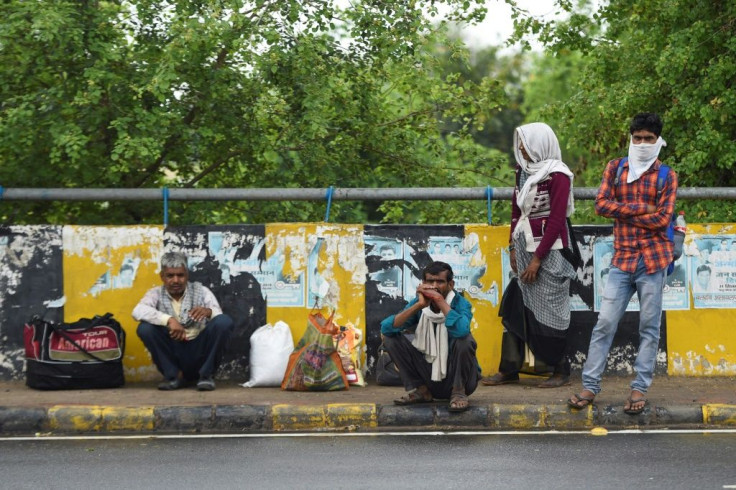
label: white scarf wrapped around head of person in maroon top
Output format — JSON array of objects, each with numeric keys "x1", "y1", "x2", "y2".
[{"x1": 514, "y1": 123, "x2": 575, "y2": 219}]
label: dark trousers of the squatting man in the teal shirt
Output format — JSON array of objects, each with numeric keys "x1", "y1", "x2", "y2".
[{"x1": 383, "y1": 335, "x2": 480, "y2": 399}]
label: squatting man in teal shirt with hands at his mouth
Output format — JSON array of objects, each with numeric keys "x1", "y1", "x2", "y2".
[{"x1": 381, "y1": 262, "x2": 480, "y2": 412}]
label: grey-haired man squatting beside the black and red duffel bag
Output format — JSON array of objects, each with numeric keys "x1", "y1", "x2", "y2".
[{"x1": 133, "y1": 252, "x2": 233, "y2": 391}]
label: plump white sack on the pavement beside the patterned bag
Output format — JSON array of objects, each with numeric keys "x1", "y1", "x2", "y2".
[{"x1": 243, "y1": 321, "x2": 294, "y2": 388}]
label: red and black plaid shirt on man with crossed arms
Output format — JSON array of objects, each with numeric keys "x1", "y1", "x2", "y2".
[{"x1": 595, "y1": 158, "x2": 677, "y2": 274}]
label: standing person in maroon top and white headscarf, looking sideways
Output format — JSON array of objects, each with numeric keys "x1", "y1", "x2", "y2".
[{"x1": 481, "y1": 123, "x2": 576, "y2": 388}]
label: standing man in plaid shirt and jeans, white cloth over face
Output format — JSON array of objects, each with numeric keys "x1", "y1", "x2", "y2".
[{"x1": 568, "y1": 113, "x2": 677, "y2": 414}]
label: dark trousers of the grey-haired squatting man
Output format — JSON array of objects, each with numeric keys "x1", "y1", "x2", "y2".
[{"x1": 137, "y1": 314, "x2": 233, "y2": 381}]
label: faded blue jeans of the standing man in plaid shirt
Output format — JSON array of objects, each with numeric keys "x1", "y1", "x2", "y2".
[{"x1": 583, "y1": 258, "x2": 667, "y2": 395}]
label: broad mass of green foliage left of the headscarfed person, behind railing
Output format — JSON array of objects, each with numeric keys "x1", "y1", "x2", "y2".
[{"x1": 0, "y1": 0, "x2": 508, "y2": 224}]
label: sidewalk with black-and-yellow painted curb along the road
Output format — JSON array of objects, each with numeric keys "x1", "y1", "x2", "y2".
[{"x1": 0, "y1": 376, "x2": 736, "y2": 436}]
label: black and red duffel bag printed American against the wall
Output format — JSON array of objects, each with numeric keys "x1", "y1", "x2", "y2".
[{"x1": 23, "y1": 313, "x2": 125, "y2": 390}]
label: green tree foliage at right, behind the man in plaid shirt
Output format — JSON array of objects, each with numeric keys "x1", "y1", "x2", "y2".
[{"x1": 516, "y1": 0, "x2": 736, "y2": 221}]
